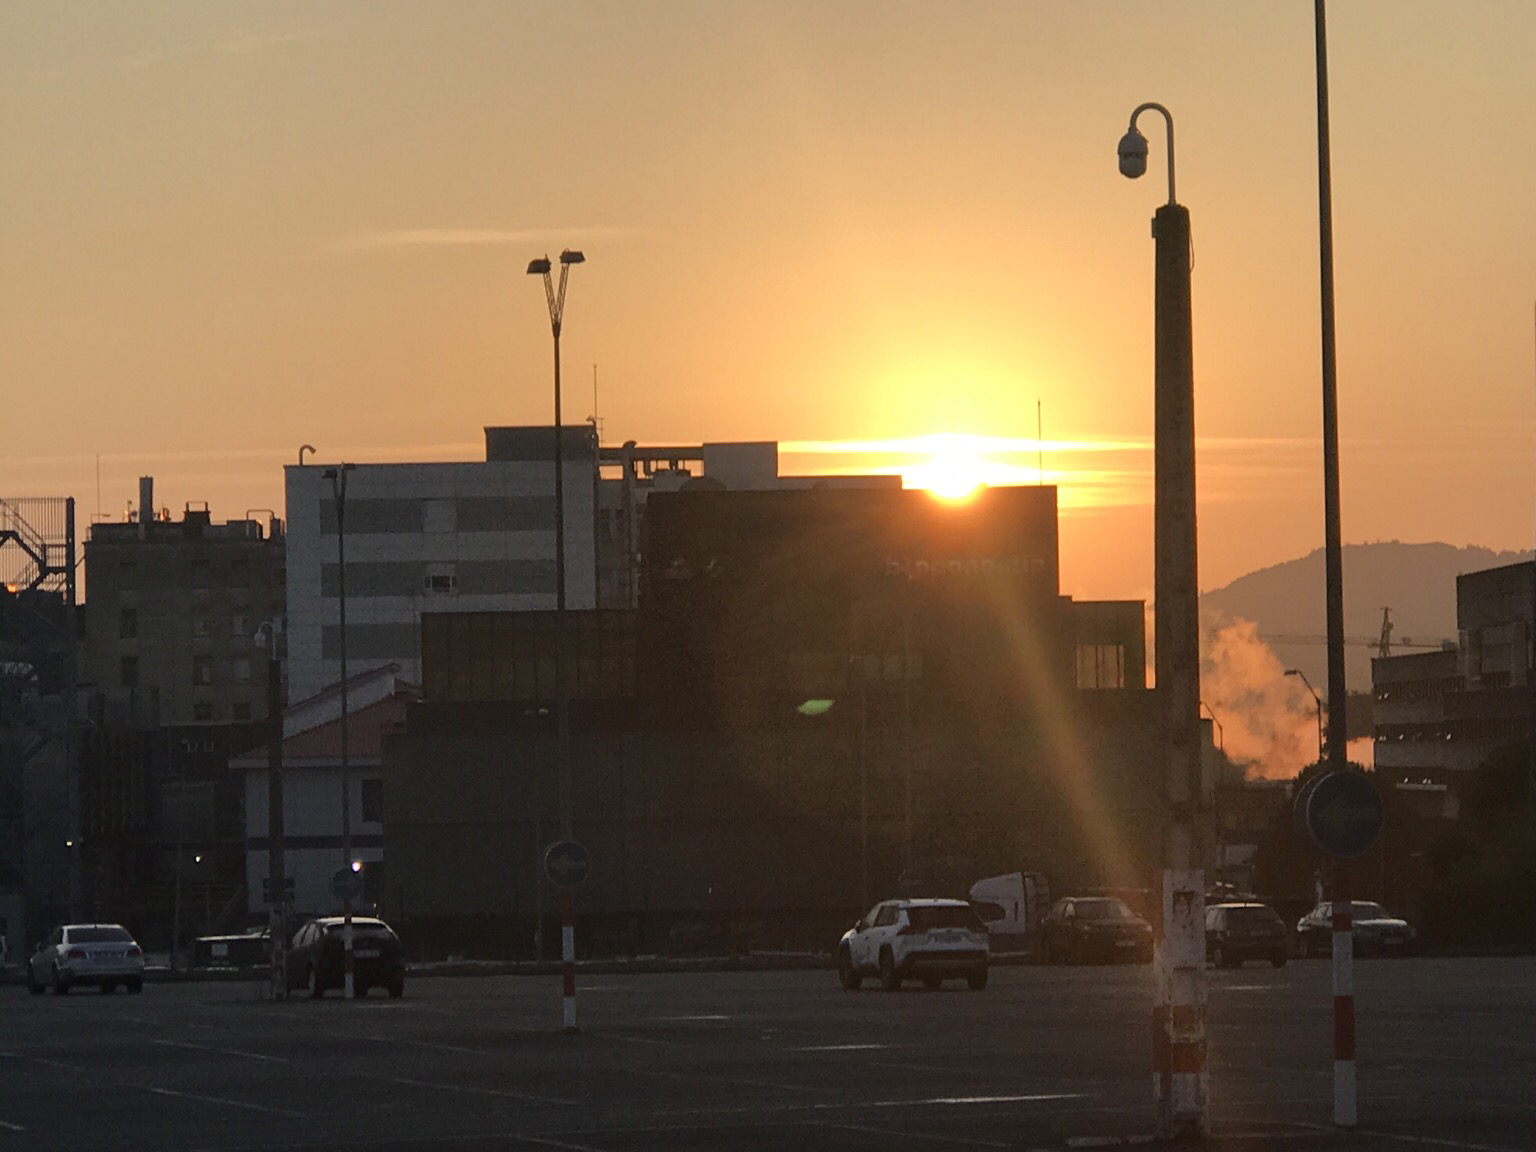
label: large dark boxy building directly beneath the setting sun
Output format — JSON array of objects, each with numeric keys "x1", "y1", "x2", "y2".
[{"x1": 384, "y1": 487, "x2": 1161, "y2": 954}]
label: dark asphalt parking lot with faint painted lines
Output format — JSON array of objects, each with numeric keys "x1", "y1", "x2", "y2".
[{"x1": 0, "y1": 957, "x2": 1536, "y2": 1152}]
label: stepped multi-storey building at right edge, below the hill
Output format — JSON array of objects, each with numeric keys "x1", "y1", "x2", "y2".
[{"x1": 1372, "y1": 562, "x2": 1536, "y2": 816}]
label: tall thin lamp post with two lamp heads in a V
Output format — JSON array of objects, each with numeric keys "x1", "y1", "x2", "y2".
[{"x1": 528, "y1": 249, "x2": 587, "y2": 1032}]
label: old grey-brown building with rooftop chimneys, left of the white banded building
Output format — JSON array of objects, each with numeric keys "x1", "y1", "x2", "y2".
[{"x1": 80, "y1": 478, "x2": 284, "y2": 728}]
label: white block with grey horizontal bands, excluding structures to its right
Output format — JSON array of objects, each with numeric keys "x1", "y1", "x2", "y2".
[{"x1": 286, "y1": 424, "x2": 598, "y2": 700}]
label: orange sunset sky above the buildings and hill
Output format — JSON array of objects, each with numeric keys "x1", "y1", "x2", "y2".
[{"x1": 0, "y1": 0, "x2": 1536, "y2": 596}]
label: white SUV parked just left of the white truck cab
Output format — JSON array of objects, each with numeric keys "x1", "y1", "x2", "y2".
[{"x1": 837, "y1": 900, "x2": 988, "y2": 992}]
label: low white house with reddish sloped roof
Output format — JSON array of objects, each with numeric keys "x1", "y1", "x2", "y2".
[{"x1": 229, "y1": 665, "x2": 418, "y2": 919}]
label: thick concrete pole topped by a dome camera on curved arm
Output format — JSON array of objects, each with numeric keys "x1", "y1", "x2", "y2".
[{"x1": 1118, "y1": 103, "x2": 1206, "y2": 1140}]
